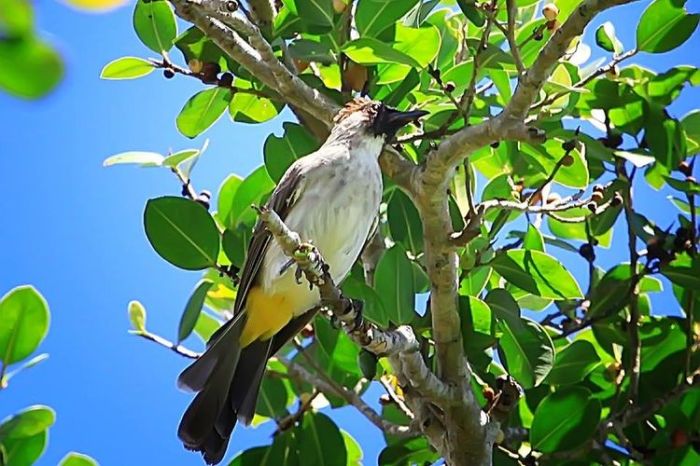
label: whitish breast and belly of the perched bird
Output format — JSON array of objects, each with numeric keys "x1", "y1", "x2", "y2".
[{"x1": 261, "y1": 139, "x2": 382, "y2": 315}]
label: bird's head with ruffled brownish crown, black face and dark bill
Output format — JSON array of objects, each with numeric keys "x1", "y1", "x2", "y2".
[{"x1": 333, "y1": 97, "x2": 428, "y2": 142}]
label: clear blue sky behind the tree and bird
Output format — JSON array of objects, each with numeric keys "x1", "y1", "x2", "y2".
[{"x1": 0, "y1": 0, "x2": 700, "y2": 466}]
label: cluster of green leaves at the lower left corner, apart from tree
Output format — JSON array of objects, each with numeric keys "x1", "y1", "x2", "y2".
[{"x1": 0, "y1": 285, "x2": 97, "y2": 466}]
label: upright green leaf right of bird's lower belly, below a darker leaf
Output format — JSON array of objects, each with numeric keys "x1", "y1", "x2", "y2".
[{"x1": 374, "y1": 244, "x2": 415, "y2": 324}]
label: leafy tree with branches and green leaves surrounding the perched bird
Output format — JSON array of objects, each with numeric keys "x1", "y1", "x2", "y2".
[{"x1": 0, "y1": 0, "x2": 700, "y2": 466}]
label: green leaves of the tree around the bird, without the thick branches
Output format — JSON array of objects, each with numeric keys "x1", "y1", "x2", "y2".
[{"x1": 103, "y1": 0, "x2": 700, "y2": 465}]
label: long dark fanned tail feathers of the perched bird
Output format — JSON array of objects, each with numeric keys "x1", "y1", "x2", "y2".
[{"x1": 177, "y1": 315, "x2": 271, "y2": 464}]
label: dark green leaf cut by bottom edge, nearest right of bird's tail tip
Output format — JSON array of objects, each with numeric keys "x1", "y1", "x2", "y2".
[{"x1": 297, "y1": 411, "x2": 348, "y2": 466}]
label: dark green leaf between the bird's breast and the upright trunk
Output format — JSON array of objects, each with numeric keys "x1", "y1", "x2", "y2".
[{"x1": 387, "y1": 189, "x2": 423, "y2": 255}]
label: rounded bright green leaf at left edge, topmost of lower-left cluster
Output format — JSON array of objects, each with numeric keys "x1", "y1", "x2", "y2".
[{"x1": 0, "y1": 285, "x2": 50, "y2": 366}]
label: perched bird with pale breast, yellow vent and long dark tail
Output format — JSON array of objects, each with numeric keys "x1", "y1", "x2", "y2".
[{"x1": 178, "y1": 97, "x2": 428, "y2": 464}]
